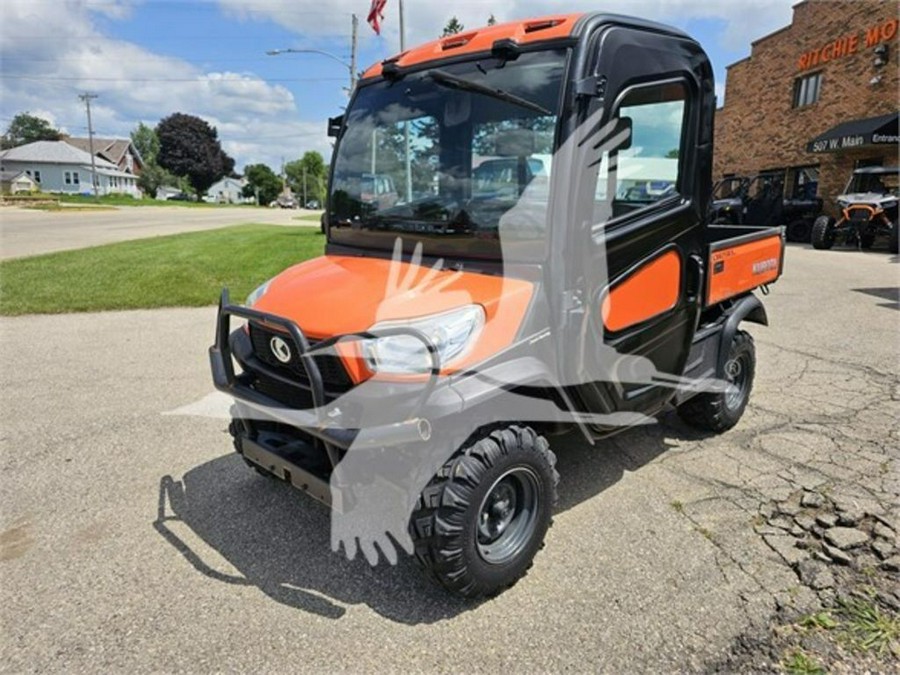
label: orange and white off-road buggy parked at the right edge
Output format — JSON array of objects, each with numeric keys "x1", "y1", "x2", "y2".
[{"x1": 812, "y1": 166, "x2": 900, "y2": 253}]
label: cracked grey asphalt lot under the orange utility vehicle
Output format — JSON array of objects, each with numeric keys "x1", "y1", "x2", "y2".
[{"x1": 0, "y1": 248, "x2": 900, "y2": 673}]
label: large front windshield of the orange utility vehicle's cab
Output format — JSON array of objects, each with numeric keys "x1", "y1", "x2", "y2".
[{"x1": 329, "y1": 50, "x2": 566, "y2": 260}]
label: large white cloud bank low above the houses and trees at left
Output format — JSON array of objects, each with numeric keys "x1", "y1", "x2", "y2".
[{"x1": 0, "y1": 0, "x2": 330, "y2": 168}]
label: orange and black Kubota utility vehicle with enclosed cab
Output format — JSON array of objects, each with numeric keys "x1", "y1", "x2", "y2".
[{"x1": 210, "y1": 13, "x2": 784, "y2": 596}]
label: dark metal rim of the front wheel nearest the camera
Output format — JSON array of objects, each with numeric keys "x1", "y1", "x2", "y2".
[{"x1": 475, "y1": 466, "x2": 541, "y2": 565}]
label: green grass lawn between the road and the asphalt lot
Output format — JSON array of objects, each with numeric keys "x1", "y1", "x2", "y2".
[{"x1": 0, "y1": 225, "x2": 325, "y2": 315}]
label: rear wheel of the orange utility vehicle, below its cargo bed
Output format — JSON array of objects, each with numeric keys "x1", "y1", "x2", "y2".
[{"x1": 678, "y1": 330, "x2": 756, "y2": 433}]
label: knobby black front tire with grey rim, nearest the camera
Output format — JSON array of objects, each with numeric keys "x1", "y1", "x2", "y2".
[{"x1": 410, "y1": 425, "x2": 559, "y2": 598}]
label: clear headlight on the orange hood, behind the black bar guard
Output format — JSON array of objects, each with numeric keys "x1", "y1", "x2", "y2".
[{"x1": 362, "y1": 305, "x2": 484, "y2": 374}]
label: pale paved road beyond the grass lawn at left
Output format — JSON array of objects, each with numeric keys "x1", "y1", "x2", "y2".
[{"x1": 0, "y1": 206, "x2": 319, "y2": 259}]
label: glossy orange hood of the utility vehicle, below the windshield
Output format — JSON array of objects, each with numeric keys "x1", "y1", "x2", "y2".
[{"x1": 254, "y1": 256, "x2": 534, "y2": 368}]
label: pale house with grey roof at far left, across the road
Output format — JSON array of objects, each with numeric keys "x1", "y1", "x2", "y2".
[{"x1": 0, "y1": 141, "x2": 141, "y2": 198}]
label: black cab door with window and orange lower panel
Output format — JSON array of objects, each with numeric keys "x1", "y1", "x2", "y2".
[{"x1": 562, "y1": 26, "x2": 714, "y2": 422}]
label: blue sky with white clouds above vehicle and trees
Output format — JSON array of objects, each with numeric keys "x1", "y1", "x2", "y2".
[{"x1": 0, "y1": 0, "x2": 794, "y2": 171}]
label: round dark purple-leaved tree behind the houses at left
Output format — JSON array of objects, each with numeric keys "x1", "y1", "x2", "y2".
[{"x1": 156, "y1": 113, "x2": 234, "y2": 194}]
